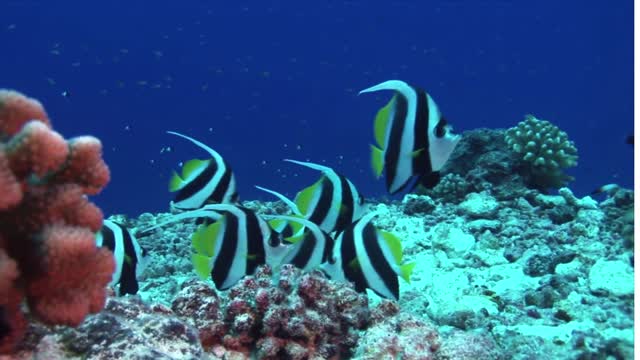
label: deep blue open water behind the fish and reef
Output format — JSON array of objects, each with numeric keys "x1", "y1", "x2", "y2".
[{"x1": 0, "y1": 0, "x2": 633, "y2": 215}]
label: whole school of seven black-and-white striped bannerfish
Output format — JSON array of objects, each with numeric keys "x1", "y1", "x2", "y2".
[{"x1": 96, "y1": 80, "x2": 460, "y2": 300}]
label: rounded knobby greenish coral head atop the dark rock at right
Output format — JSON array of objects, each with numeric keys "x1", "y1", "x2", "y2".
[{"x1": 505, "y1": 115, "x2": 578, "y2": 189}]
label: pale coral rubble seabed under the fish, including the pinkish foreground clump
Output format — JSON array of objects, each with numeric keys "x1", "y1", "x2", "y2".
[{"x1": 6, "y1": 182, "x2": 634, "y2": 360}]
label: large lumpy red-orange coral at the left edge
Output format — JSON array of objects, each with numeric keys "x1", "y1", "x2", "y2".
[{"x1": 0, "y1": 90, "x2": 115, "y2": 353}]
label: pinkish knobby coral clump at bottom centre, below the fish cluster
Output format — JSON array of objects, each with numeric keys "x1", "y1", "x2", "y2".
[{"x1": 172, "y1": 265, "x2": 369, "y2": 359}]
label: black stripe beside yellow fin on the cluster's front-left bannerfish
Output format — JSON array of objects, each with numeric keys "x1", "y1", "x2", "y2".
[{"x1": 211, "y1": 211, "x2": 240, "y2": 290}]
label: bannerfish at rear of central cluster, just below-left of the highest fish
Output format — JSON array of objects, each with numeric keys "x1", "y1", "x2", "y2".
[{"x1": 257, "y1": 159, "x2": 364, "y2": 233}]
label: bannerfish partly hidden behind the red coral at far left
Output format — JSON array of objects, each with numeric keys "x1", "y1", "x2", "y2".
[{"x1": 96, "y1": 220, "x2": 149, "y2": 296}]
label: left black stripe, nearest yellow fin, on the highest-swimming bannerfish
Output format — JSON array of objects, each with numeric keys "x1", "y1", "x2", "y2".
[{"x1": 384, "y1": 94, "x2": 409, "y2": 193}]
